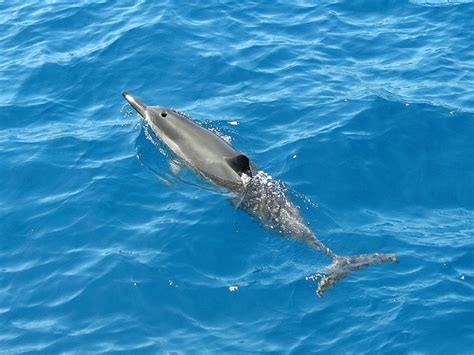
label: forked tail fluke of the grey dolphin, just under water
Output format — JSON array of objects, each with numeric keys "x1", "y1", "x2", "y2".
[{"x1": 316, "y1": 253, "x2": 398, "y2": 297}]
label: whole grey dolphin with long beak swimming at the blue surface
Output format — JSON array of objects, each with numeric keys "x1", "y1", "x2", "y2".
[{"x1": 122, "y1": 92, "x2": 398, "y2": 296}]
